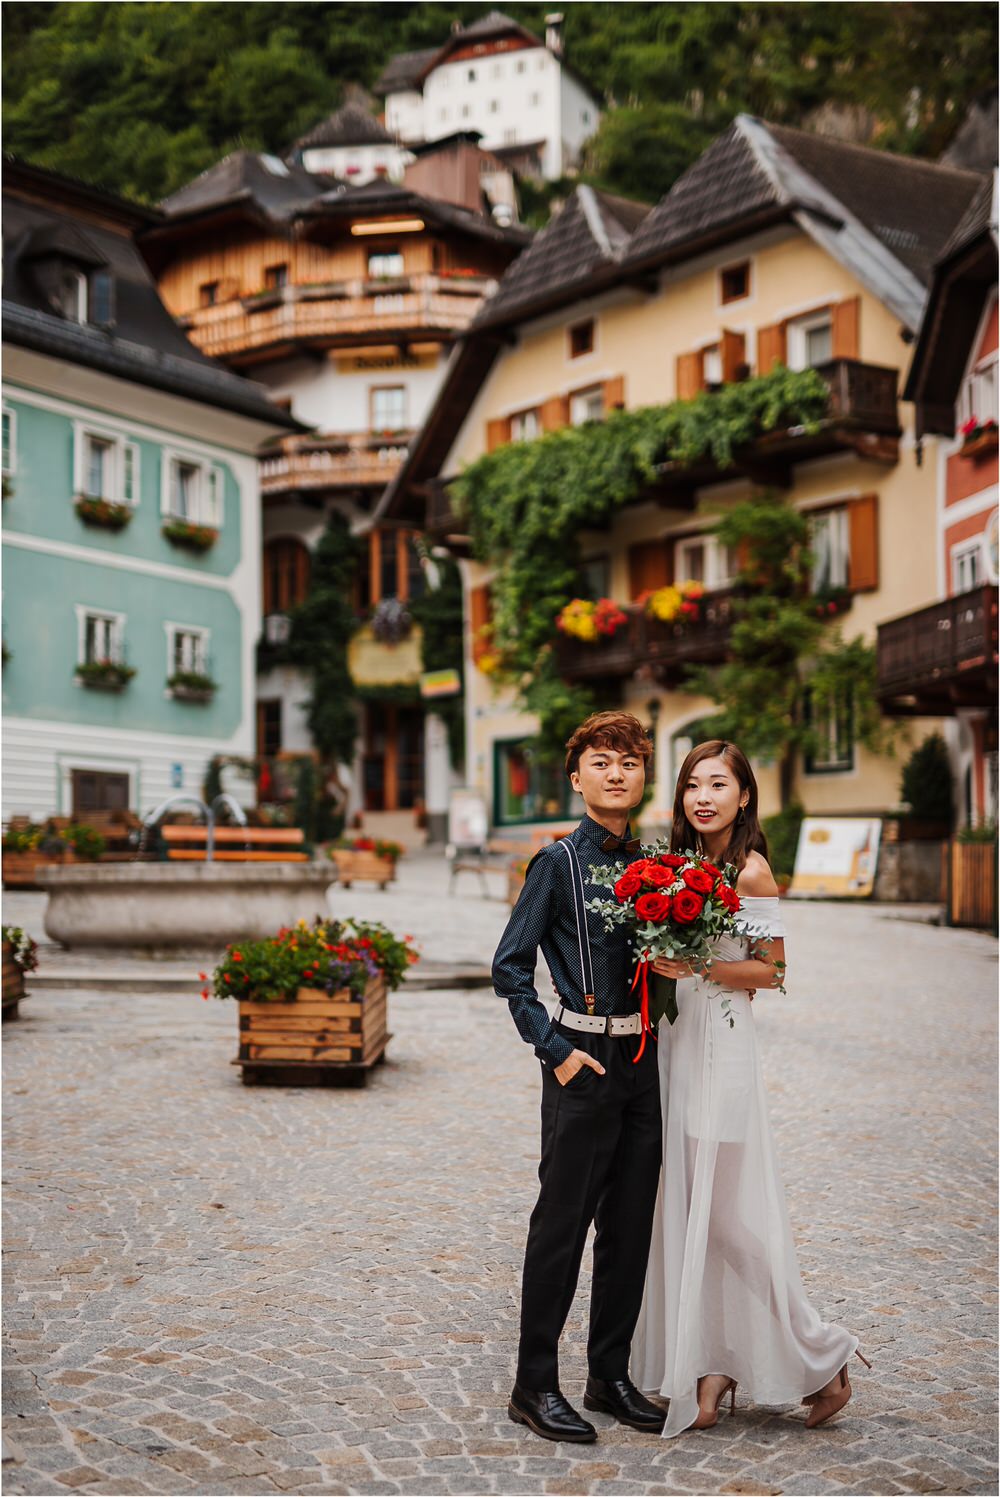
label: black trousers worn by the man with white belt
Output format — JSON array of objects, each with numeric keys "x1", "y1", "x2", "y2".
[{"x1": 518, "y1": 1028, "x2": 663, "y2": 1391}]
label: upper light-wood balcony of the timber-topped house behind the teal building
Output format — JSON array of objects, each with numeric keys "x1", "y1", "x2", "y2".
[{"x1": 178, "y1": 275, "x2": 496, "y2": 364}]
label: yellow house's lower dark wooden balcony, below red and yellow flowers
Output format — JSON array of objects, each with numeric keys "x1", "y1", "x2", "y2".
[{"x1": 555, "y1": 588, "x2": 734, "y2": 686}]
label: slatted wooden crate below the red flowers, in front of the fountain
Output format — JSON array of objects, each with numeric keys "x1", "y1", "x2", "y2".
[{"x1": 234, "y1": 975, "x2": 391, "y2": 1087}]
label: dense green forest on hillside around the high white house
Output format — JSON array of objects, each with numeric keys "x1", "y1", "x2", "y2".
[{"x1": 3, "y1": 0, "x2": 997, "y2": 201}]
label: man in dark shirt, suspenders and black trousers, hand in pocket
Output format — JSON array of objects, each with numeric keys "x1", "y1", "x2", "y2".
[{"x1": 493, "y1": 713, "x2": 665, "y2": 1443}]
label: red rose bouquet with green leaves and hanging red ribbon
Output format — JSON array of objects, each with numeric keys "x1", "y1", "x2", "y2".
[{"x1": 587, "y1": 849, "x2": 759, "y2": 1060}]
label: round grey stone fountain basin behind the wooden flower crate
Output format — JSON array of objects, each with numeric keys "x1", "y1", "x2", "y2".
[{"x1": 37, "y1": 862, "x2": 337, "y2": 954}]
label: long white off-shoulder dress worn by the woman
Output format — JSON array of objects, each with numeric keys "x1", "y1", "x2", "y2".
[{"x1": 632, "y1": 897, "x2": 858, "y2": 1437}]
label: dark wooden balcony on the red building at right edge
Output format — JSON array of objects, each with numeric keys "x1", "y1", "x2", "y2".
[{"x1": 876, "y1": 585, "x2": 997, "y2": 717}]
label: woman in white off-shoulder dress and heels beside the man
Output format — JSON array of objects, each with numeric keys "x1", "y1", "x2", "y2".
[{"x1": 632, "y1": 740, "x2": 868, "y2": 1437}]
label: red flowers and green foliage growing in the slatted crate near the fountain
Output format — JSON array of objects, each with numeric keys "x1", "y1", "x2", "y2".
[{"x1": 206, "y1": 918, "x2": 419, "y2": 1003}]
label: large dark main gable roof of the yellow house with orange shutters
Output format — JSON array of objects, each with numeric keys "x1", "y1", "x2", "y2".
[{"x1": 626, "y1": 114, "x2": 981, "y2": 328}]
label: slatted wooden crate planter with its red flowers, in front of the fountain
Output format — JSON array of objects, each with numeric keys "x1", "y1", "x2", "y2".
[{"x1": 199, "y1": 918, "x2": 418, "y2": 1085}]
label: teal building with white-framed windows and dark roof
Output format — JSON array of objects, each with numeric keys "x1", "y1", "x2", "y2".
[{"x1": 3, "y1": 165, "x2": 299, "y2": 820}]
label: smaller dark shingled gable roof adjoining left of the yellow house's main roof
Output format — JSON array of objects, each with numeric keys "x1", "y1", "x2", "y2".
[{"x1": 472, "y1": 187, "x2": 650, "y2": 332}]
